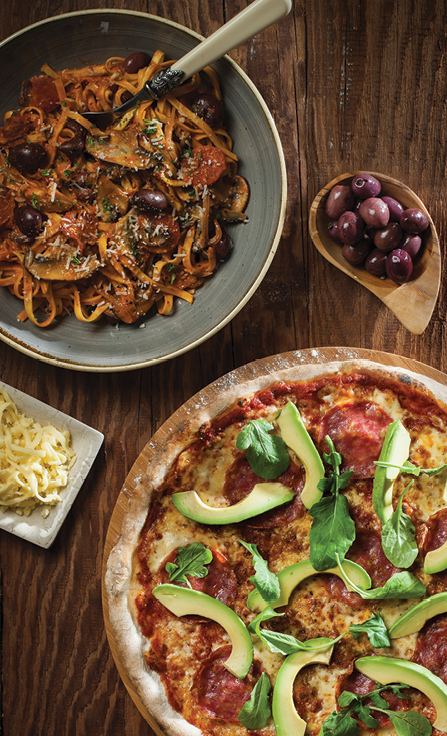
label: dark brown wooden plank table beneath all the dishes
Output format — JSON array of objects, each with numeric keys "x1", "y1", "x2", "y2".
[{"x1": 0, "y1": 0, "x2": 447, "y2": 736}]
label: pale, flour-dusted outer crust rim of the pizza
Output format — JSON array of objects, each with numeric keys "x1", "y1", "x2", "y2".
[{"x1": 104, "y1": 356, "x2": 447, "y2": 736}]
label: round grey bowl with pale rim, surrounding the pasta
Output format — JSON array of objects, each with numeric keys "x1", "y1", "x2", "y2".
[{"x1": 0, "y1": 10, "x2": 286, "y2": 372}]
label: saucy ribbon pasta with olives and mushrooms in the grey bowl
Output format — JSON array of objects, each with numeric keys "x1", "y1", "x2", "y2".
[{"x1": 0, "y1": 51, "x2": 249, "y2": 327}]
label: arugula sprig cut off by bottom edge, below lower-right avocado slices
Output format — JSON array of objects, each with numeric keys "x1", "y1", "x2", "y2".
[{"x1": 320, "y1": 684, "x2": 432, "y2": 736}]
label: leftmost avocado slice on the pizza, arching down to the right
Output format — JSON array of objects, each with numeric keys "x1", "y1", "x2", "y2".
[{"x1": 152, "y1": 583, "x2": 253, "y2": 680}]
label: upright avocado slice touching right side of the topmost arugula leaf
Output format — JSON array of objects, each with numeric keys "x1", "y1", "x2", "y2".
[{"x1": 276, "y1": 401, "x2": 324, "y2": 509}]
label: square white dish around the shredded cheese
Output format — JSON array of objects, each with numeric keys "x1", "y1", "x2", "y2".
[{"x1": 0, "y1": 381, "x2": 104, "y2": 549}]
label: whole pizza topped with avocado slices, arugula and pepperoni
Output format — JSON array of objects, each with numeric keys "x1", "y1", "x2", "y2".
[{"x1": 105, "y1": 360, "x2": 447, "y2": 736}]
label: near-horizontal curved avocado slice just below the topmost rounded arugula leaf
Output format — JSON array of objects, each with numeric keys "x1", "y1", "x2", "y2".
[{"x1": 172, "y1": 483, "x2": 295, "y2": 524}]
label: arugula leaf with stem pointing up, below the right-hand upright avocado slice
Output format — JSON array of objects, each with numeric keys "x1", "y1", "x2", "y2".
[{"x1": 382, "y1": 481, "x2": 418, "y2": 567}]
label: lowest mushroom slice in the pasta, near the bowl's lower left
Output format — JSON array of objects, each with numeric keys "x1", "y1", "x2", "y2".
[{"x1": 23, "y1": 246, "x2": 101, "y2": 281}]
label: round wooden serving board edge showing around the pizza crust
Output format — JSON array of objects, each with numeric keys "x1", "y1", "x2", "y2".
[{"x1": 102, "y1": 348, "x2": 447, "y2": 736}]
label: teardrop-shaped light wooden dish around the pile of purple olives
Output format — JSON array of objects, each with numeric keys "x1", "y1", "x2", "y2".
[{"x1": 309, "y1": 171, "x2": 441, "y2": 335}]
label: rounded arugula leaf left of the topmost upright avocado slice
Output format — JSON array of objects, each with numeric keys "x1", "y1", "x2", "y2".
[{"x1": 236, "y1": 419, "x2": 290, "y2": 480}]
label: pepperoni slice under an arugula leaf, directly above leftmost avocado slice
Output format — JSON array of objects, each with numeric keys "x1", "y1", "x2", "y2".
[{"x1": 161, "y1": 547, "x2": 237, "y2": 605}]
